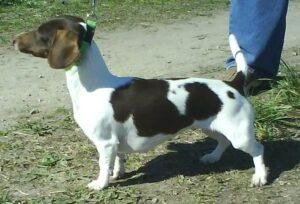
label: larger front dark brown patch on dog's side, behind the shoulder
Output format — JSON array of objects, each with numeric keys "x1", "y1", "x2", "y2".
[{"x1": 111, "y1": 79, "x2": 193, "y2": 137}]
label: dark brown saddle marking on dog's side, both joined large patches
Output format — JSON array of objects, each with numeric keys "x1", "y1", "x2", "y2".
[{"x1": 110, "y1": 79, "x2": 222, "y2": 137}]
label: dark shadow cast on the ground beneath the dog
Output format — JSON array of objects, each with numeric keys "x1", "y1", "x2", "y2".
[{"x1": 113, "y1": 138, "x2": 300, "y2": 186}]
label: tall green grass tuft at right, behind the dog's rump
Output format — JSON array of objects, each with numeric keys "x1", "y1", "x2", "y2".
[{"x1": 251, "y1": 61, "x2": 300, "y2": 140}]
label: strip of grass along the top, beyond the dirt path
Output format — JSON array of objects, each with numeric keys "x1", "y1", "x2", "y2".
[{"x1": 0, "y1": 0, "x2": 229, "y2": 44}]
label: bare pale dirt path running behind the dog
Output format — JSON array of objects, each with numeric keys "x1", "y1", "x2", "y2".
[{"x1": 0, "y1": 1, "x2": 300, "y2": 128}]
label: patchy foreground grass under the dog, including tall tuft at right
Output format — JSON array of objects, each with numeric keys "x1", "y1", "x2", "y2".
[{"x1": 0, "y1": 67, "x2": 300, "y2": 203}]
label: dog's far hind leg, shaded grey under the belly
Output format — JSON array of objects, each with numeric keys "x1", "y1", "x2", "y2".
[{"x1": 200, "y1": 130, "x2": 230, "y2": 163}]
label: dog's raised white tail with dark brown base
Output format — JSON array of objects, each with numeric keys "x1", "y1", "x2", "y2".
[{"x1": 229, "y1": 34, "x2": 248, "y2": 95}]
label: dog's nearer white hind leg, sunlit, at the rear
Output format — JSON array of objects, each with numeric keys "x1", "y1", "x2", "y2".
[{"x1": 218, "y1": 120, "x2": 267, "y2": 186}]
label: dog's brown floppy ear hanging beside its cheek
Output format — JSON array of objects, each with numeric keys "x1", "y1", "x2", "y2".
[{"x1": 48, "y1": 30, "x2": 80, "y2": 69}]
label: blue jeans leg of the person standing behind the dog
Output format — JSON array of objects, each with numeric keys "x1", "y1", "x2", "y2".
[{"x1": 227, "y1": 0, "x2": 289, "y2": 77}]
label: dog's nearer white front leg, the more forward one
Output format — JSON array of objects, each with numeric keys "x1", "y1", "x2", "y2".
[{"x1": 88, "y1": 141, "x2": 117, "y2": 190}]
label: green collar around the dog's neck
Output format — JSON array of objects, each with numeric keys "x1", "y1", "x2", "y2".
[{"x1": 65, "y1": 20, "x2": 96, "y2": 71}]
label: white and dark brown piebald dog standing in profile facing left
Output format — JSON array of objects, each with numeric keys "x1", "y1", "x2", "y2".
[{"x1": 13, "y1": 16, "x2": 267, "y2": 190}]
